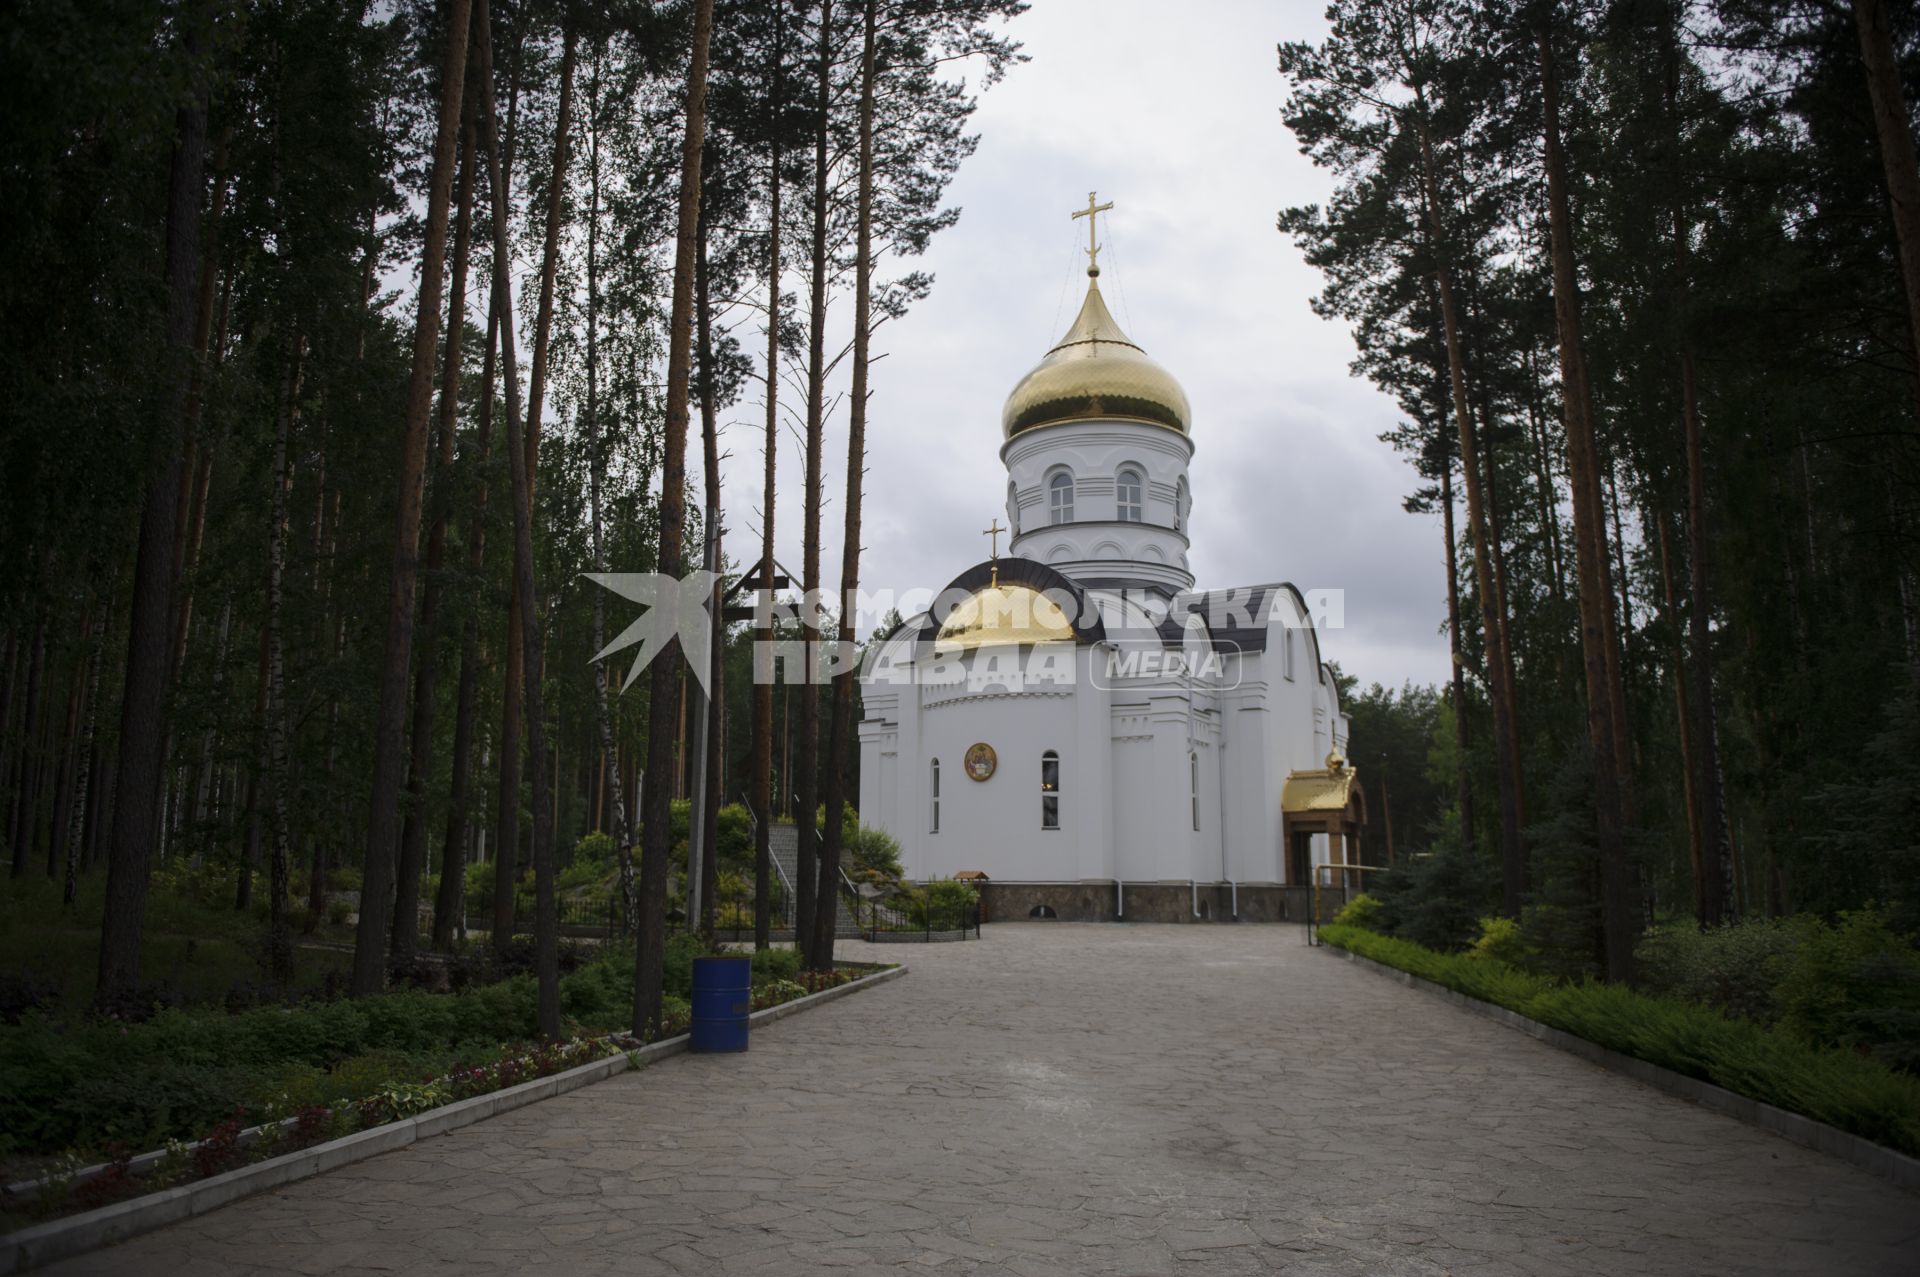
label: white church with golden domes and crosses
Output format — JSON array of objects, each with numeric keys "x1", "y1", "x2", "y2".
[{"x1": 860, "y1": 198, "x2": 1369, "y2": 922}]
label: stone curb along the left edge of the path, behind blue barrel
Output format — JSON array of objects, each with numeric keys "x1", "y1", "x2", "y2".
[{"x1": 0, "y1": 966, "x2": 906, "y2": 1273}]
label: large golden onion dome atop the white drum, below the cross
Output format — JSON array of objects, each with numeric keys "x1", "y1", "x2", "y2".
[{"x1": 1000, "y1": 269, "x2": 1188, "y2": 438}]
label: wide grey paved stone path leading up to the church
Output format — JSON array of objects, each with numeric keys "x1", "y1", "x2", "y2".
[{"x1": 56, "y1": 924, "x2": 1920, "y2": 1277}]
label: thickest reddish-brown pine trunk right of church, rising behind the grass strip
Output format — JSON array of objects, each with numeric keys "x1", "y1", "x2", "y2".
[{"x1": 1538, "y1": 27, "x2": 1638, "y2": 981}]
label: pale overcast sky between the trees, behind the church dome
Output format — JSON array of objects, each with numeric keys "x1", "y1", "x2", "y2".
[{"x1": 714, "y1": 0, "x2": 1448, "y2": 686}]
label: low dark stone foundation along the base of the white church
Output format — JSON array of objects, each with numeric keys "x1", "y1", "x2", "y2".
[{"x1": 979, "y1": 879, "x2": 1344, "y2": 922}]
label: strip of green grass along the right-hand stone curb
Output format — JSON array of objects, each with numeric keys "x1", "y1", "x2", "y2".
[{"x1": 1321, "y1": 926, "x2": 1920, "y2": 1156}]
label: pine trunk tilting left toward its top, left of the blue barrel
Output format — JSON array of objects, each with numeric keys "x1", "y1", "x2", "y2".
[{"x1": 474, "y1": 0, "x2": 561, "y2": 1039}]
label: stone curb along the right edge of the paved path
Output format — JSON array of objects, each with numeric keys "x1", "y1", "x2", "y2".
[{"x1": 1329, "y1": 945, "x2": 1920, "y2": 1189}]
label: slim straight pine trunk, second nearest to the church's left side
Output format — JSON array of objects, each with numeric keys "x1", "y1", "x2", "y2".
[{"x1": 793, "y1": 0, "x2": 833, "y2": 966}]
